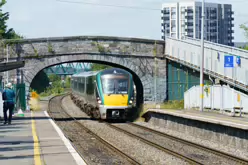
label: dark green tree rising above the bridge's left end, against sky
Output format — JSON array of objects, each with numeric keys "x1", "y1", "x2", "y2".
[{"x1": 0, "y1": 0, "x2": 23, "y2": 39}]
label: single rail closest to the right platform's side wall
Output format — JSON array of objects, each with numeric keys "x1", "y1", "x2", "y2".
[{"x1": 129, "y1": 123, "x2": 248, "y2": 165}]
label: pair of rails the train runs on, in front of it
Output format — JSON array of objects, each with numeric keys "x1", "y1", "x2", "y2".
[{"x1": 106, "y1": 123, "x2": 248, "y2": 165}]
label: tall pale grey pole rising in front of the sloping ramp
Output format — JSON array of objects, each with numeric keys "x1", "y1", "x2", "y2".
[{"x1": 200, "y1": 0, "x2": 205, "y2": 111}]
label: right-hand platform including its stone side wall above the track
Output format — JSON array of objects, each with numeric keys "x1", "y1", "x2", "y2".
[{"x1": 143, "y1": 109, "x2": 248, "y2": 155}]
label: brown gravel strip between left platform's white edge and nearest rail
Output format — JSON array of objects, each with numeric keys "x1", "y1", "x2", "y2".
[{"x1": 49, "y1": 97, "x2": 133, "y2": 165}]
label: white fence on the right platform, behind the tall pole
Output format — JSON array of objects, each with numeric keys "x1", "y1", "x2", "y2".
[{"x1": 184, "y1": 85, "x2": 248, "y2": 113}]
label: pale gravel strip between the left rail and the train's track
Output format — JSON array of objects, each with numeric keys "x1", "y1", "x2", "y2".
[{"x1": 62, "y1": 96, "x2": 188, "y2": 165}]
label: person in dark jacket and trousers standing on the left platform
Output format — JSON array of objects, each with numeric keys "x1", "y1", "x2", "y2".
[{"x1": 2, "y1": 83, "x2": 15, "y2": 124}]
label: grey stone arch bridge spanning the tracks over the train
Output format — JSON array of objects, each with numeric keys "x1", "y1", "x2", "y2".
[{"x1": 2, "y1": 36, "x2": 167, "y2": 103}]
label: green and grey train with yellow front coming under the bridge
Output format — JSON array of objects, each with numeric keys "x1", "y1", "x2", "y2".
[{"x1": 71, "y1": 68, "x2": 135, "y2": 120}]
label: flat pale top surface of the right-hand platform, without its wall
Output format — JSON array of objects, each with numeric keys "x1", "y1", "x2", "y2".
[{"x1": 147, "y1": 109, "x2": 248, "y2": 130}]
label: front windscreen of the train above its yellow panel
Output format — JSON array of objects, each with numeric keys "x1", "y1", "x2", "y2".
[{"x1": 102, "y1": 77, "x2": 128, "y2": 94}]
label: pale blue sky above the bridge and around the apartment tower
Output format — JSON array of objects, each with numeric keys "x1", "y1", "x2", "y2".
[{"x1": 3, "y1": 0, "x2": 248, "y2": 42}]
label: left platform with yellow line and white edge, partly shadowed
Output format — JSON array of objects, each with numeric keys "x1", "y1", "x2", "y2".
[{"x1": 0, "y1": 111, "x2": 85, "y2": 165}]
